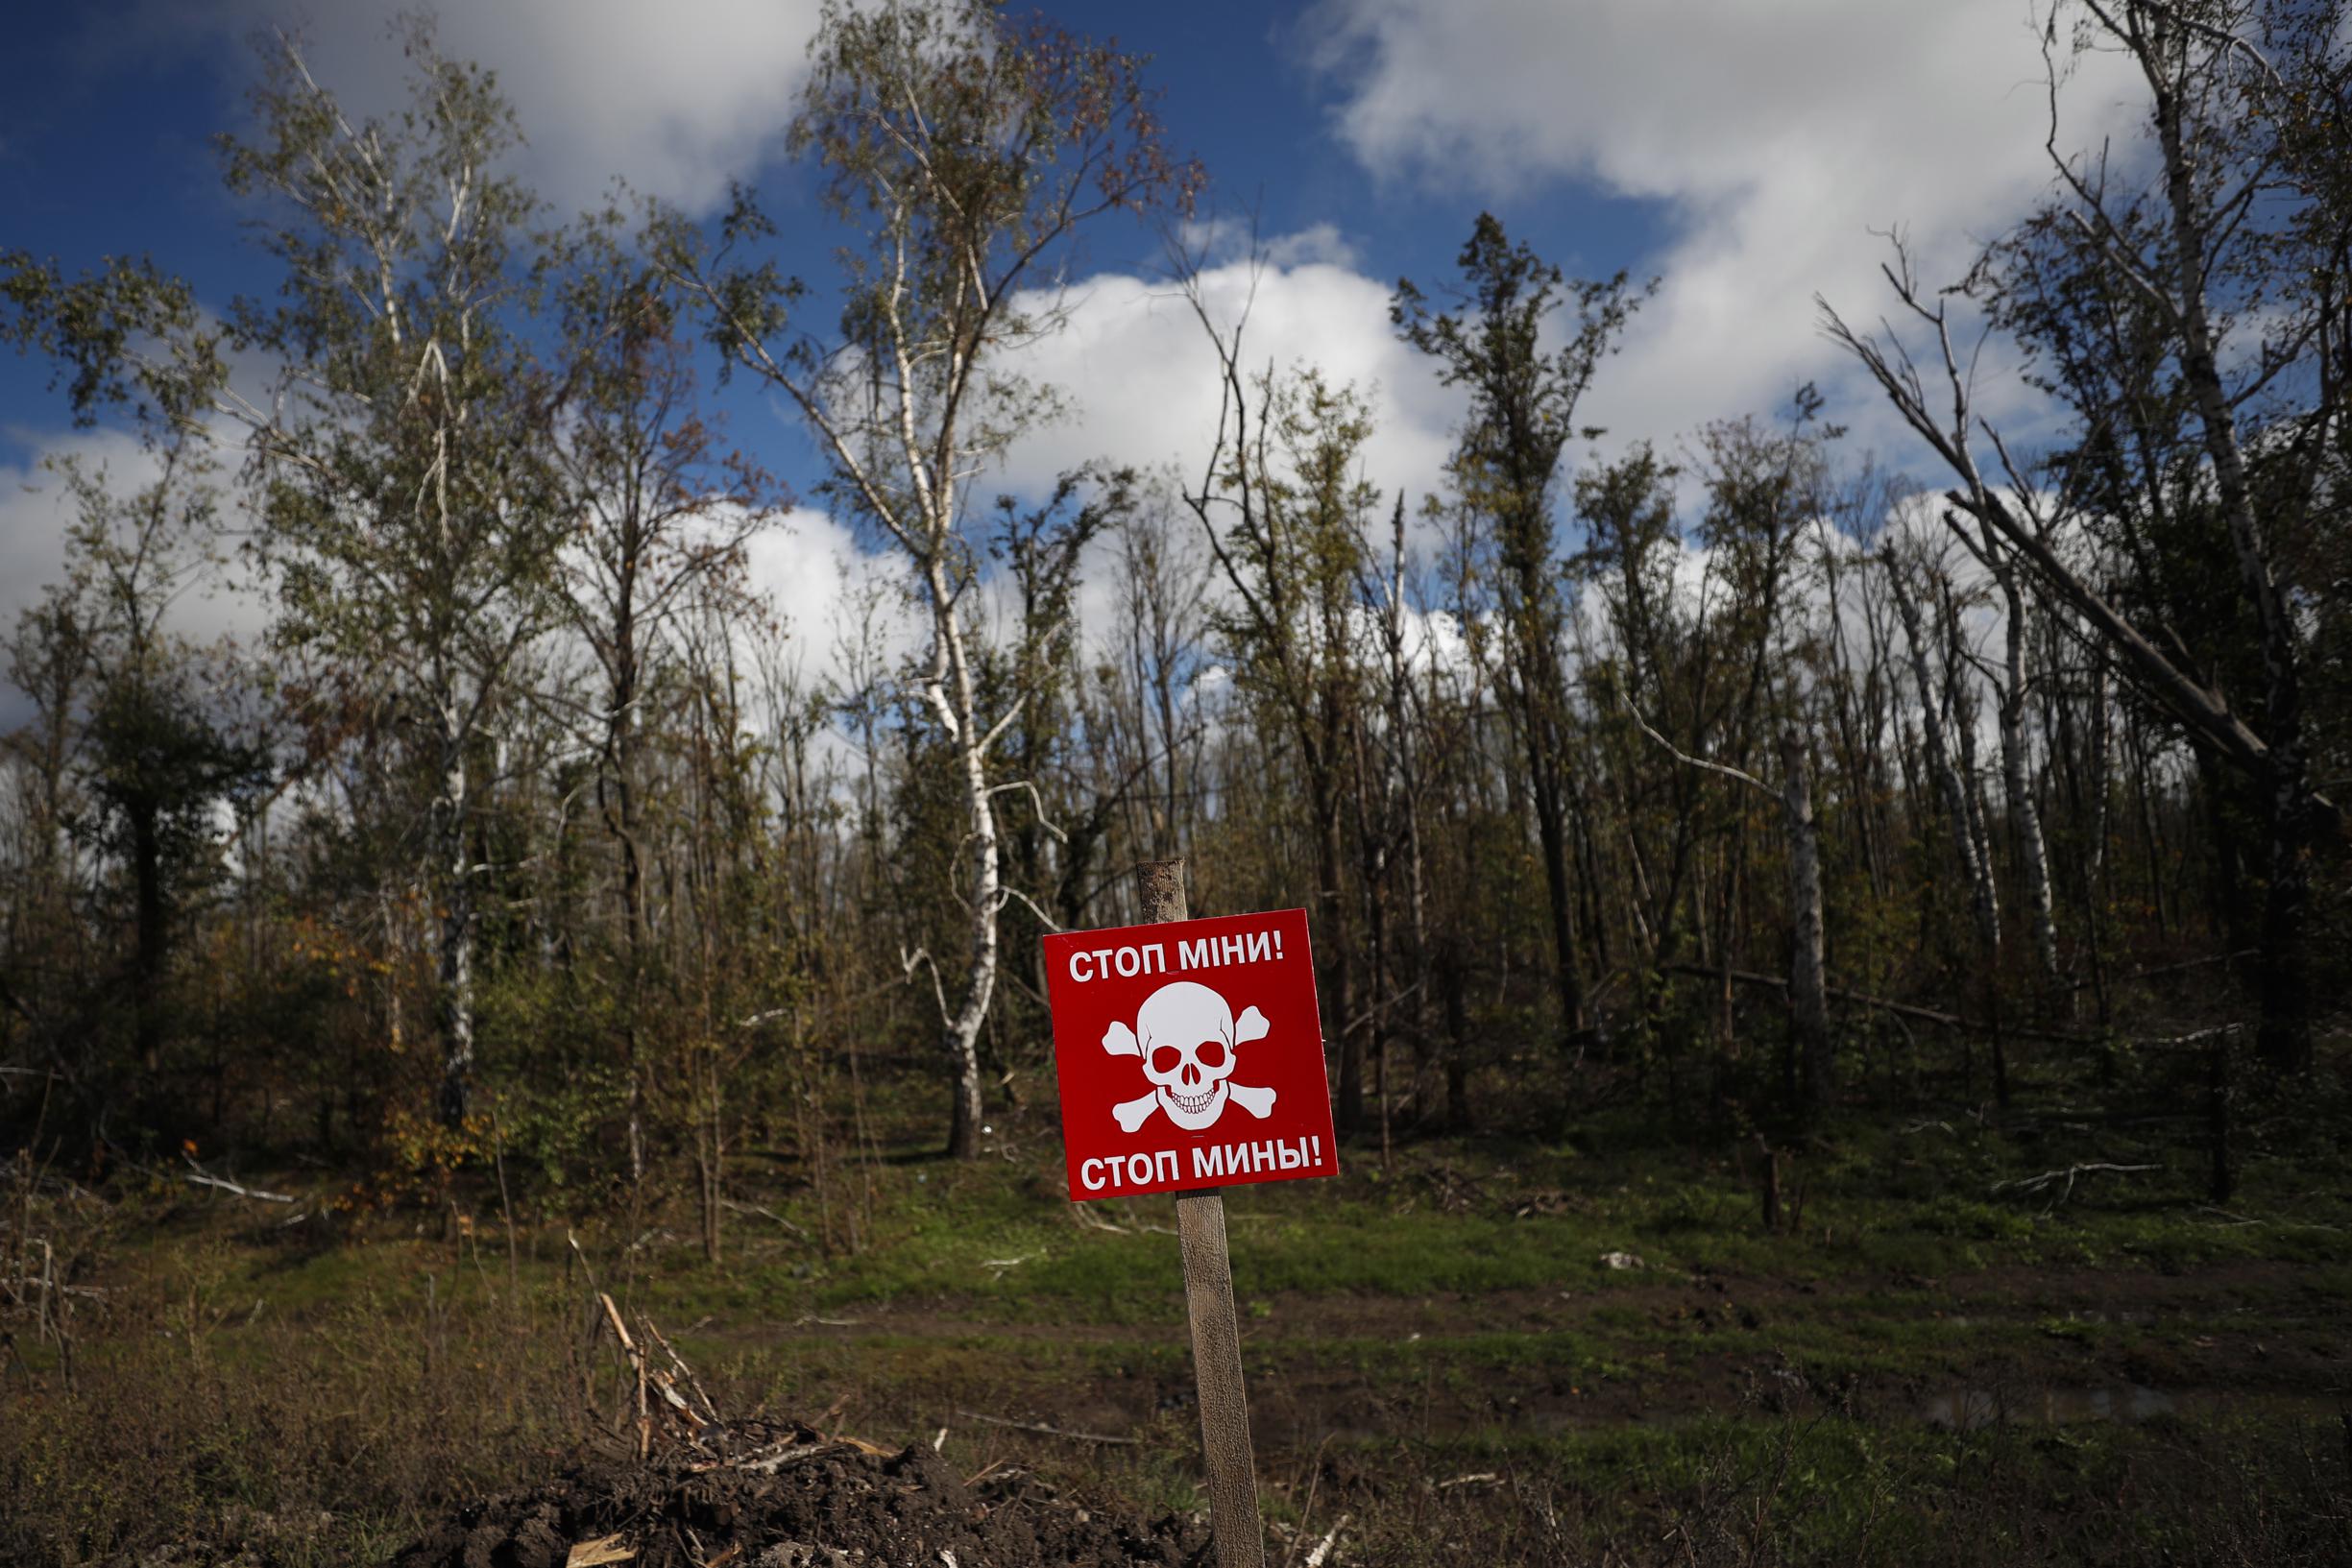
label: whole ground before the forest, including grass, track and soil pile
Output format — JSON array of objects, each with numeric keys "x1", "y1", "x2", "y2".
[{"x1": 0, "y1": 1123, "x2": 2352, "y2": 1568}]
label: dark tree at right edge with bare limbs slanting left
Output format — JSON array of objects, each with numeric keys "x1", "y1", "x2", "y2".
[{"x1": 1828, "y1": 0, "x2": 2352, "y2": 1070}]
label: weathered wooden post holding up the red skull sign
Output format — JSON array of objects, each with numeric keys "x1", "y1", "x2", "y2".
[{"x1": 1136, "y1": 860, "x2": 1266, "y2": 1568}]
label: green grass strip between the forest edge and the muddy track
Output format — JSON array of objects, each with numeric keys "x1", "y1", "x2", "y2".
[{"x1": 597, "y1": 1114, "x2": 2352, "y2": 1323}]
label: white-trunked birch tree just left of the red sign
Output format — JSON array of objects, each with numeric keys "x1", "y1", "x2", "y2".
[{"x1": 670, "y1": 0, "x2": 1193, "y2": 1157}]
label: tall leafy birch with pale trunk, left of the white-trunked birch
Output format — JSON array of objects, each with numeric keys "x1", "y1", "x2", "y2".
[{"x1": 221, "y1": 23, "x2": 565, "y2": 1126}]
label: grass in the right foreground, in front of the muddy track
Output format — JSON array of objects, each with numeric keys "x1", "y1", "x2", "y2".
[{"x1": 1326, "y1": 1415, "x2": 2352, "y2": 1566}]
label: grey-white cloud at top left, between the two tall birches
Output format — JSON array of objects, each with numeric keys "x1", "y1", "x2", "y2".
[{"x1": 130, "y1": 0, "x2": 818, "y2": 211}]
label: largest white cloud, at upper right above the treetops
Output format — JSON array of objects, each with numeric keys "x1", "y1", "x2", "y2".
[{"x1": 1308, "y1": 0, "x2": 2126, "y2": 445}]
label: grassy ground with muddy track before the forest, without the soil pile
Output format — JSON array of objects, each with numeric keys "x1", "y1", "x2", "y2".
[{"x1": 0, "y1": 1067, "x2": 2352, "y2": 1563}]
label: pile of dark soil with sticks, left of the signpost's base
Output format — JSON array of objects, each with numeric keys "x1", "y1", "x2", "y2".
[{"x1": 393, "y1": 1422, "x2": 1206, "y2": 1568}]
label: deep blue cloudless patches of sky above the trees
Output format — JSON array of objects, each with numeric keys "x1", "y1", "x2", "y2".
[{"x1": 0, "y1": 0, "x2": 1672, "y2": 461}]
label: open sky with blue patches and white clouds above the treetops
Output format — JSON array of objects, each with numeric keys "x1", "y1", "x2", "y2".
[{"x1": 0, "y1": 0, "x2": 2112, "y2": 682}]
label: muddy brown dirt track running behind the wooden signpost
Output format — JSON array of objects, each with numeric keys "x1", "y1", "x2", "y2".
[{"x1": 738, "y1": 1260, "x2": 2352, "y2": 1455}]
